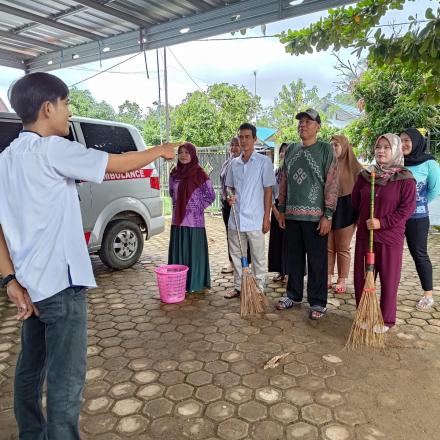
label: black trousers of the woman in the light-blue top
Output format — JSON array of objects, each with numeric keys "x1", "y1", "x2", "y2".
[{"x1": 405, "y1": 217, "x2": 432, "y2": 291}]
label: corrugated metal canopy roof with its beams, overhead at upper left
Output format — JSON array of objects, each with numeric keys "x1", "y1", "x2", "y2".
[{"x1": 0, "y1": 0, "x2": 354, "y2": 72}]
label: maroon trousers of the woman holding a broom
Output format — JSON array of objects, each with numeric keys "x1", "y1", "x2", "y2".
[{"x1": 353, "y1": 238, "x2": 403, "y2": 327}]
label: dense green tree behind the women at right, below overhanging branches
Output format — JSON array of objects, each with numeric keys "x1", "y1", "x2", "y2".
[{"x1": 346, "y1": 62, "x2": 440, "y2": 157}]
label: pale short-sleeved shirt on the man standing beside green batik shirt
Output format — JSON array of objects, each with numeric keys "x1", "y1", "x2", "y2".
[{"x1": 226, "y1": 152, "x2": 276, "y2": 232}]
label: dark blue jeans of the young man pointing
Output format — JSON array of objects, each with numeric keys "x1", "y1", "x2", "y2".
[{"x1": 14, "y1": 288, "x2": 87, "y2": 440}]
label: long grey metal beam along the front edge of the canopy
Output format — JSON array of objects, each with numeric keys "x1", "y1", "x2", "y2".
[{"x1": 23, "y1": 0, "x2": 354, "y2": 71}]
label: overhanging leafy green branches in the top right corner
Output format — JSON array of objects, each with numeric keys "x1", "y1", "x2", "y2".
[{"x1": 280, "y1": 0, "x2": 440, "y2": 104}]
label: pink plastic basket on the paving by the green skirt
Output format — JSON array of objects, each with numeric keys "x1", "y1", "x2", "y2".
[{"x1": 154, "y1": 264, "x2": 189, "y2": 304}]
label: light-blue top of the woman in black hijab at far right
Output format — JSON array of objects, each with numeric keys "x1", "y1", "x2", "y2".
[{"x1": 406, "y1": 160, "x2": 440, "y2": 218}]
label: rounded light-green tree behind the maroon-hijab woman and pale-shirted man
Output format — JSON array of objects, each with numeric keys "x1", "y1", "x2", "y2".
[{"x1": 172, "y1": 84, "x2": 260, "y2": 147}]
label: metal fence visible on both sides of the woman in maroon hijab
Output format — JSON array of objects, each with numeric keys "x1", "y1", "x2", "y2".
[{"x1": 156, "y1": 145, "x2": 228, "y2": 215}]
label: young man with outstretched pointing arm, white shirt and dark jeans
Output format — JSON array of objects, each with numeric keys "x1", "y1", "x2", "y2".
[{"x1": 0, "y1": 73, "x2": 175, "y2": 440}]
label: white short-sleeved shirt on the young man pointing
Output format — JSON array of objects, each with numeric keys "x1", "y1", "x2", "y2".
[{"x1": 0, "y1": 132, "x2": 108, "y2": 302}]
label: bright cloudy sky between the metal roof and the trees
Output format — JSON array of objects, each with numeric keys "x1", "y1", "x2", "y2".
[{"x1": 0, "y1": 0, "x2": 432, "y2": 109}]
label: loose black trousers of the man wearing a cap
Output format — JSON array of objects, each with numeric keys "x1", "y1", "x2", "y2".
[{"x1": 285, "y1": 220, "x2": 327, "y2": 307}]
